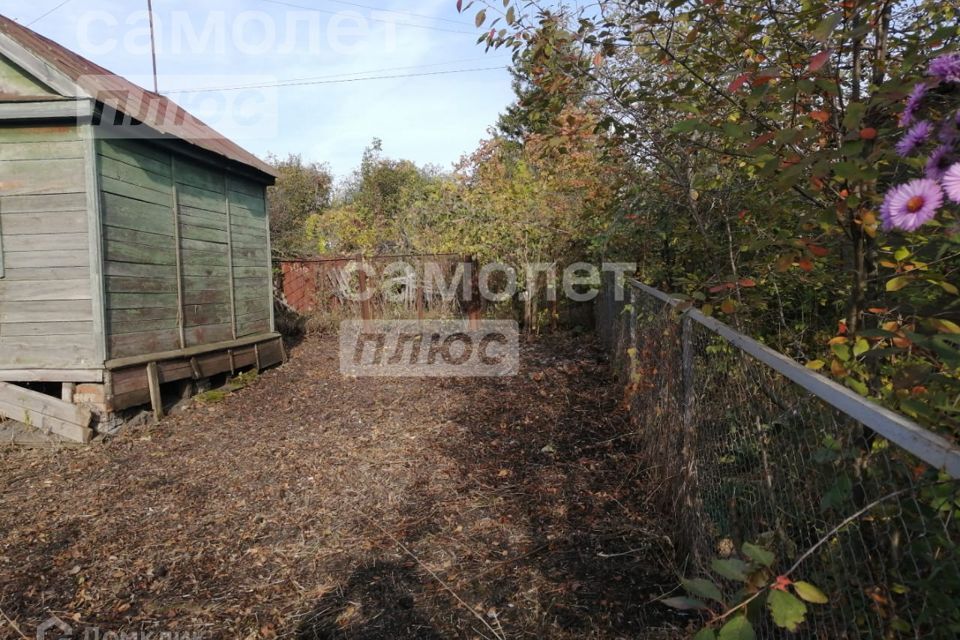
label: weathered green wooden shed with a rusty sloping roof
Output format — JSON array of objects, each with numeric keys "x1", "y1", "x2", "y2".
[{"x1": 0, "y1": 16, "x2": 283, "y2": 441}]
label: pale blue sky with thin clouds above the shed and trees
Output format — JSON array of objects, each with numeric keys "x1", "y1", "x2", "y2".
[{"x1": 0, "y1": 0, "x2": 513, "y2": 178}]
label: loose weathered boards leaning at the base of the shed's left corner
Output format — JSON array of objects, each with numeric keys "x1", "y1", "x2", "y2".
[{"x1": 0, "y1": 382, "x2": 93, "y2": 443}]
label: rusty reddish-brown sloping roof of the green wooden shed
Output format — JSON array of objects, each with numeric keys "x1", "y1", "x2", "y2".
[{"x1": 0, "y1": 15, "x2": 277, "y2": 177}]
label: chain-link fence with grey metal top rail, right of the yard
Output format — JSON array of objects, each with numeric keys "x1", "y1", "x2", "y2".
[{"x1": 597, "y1": 282, "x2": 960, "y2": 638}]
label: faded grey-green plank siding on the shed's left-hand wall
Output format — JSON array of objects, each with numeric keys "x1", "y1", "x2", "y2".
[{"x1": 0, "y1": 126, "x2": 96, "y2": 370}]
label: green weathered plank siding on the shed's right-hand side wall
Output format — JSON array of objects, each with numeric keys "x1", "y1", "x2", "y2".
[{"x1": 98, "y1": 140, "x2": 272, "y2": 358}]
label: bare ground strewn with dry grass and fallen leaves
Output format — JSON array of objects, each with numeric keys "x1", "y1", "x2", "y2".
[{"x1": 0, "y1": 336, "x2": 688, "y2": 639}]
